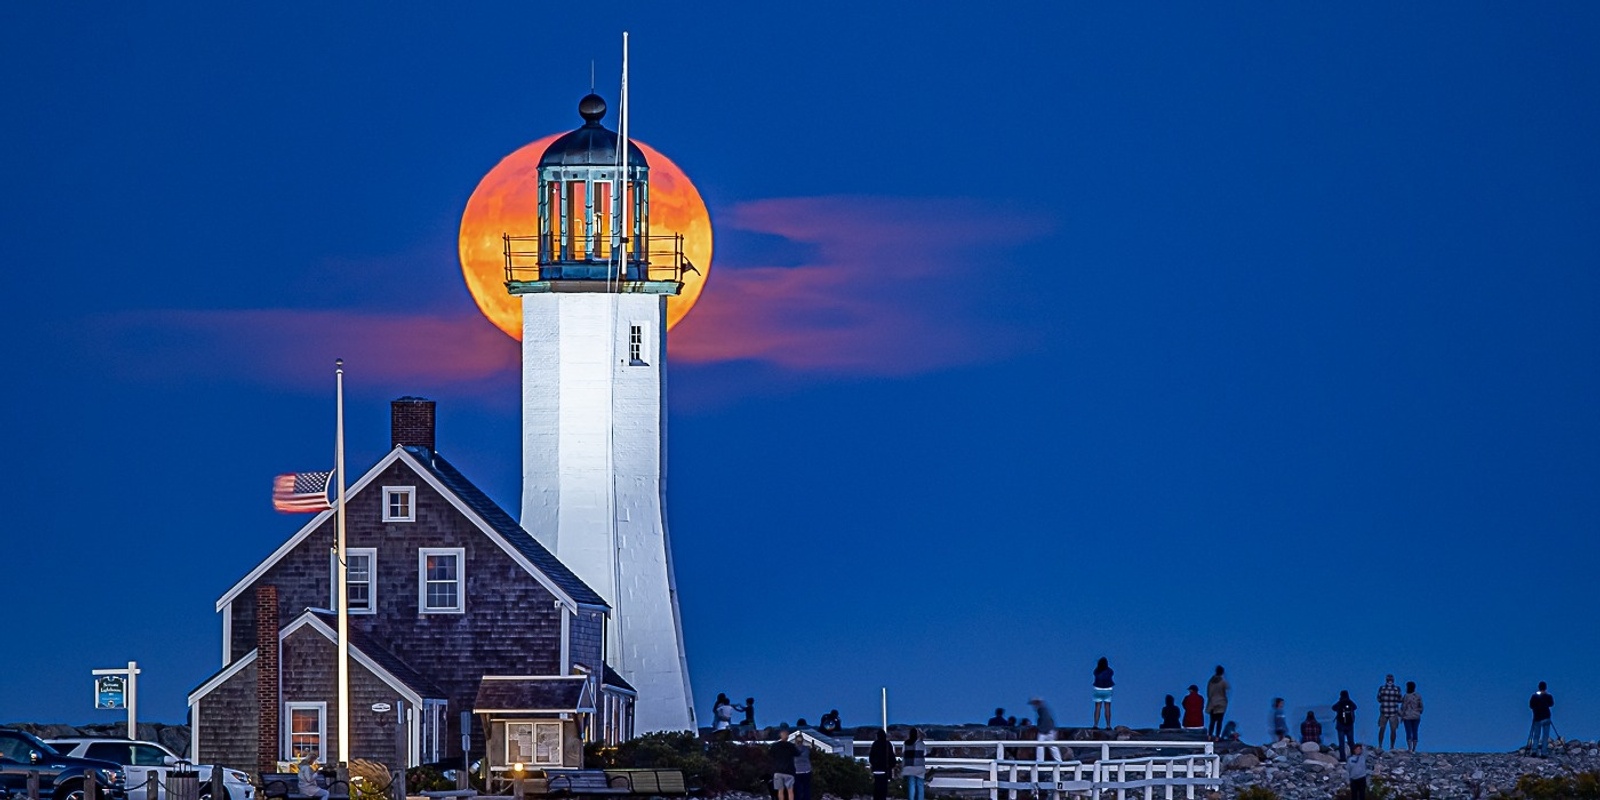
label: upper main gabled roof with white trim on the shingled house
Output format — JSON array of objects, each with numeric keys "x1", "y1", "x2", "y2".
[{"x1": 216, "y1": 446, "x2": 610, "y2": 611}]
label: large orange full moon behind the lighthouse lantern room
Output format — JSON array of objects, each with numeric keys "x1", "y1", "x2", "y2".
[{"x1": 461, "y1": 133, "x2": 710, "y2": 339}]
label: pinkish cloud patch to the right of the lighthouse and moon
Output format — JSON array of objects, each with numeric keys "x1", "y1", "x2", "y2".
[{"x1": 669, "y1": 197, "x2": 1050, "y2": 376}]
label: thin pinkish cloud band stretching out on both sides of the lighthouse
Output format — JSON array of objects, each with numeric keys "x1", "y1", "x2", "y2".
[{"x1": 90, "y1": 197, "x2": 1050, "y2": 394}]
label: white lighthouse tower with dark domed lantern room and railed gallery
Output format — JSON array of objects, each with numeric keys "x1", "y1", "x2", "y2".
[{"x1": 506, "y1": 94, "x2": 694, "y2": 733}]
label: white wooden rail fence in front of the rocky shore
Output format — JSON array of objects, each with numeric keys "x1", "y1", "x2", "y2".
[{"x1": 797, "y1": 731, "x2": 1222, "y2": 800}]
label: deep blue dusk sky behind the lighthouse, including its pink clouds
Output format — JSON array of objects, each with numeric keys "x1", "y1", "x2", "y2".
[{"x1": 0, "y1": 2, "x2": 1600, "y2": 749}]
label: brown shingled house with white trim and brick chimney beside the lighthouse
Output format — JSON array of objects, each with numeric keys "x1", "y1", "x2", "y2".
[{"x1": 189, "y1": 397, "x2": 634, "y2": 771}]
